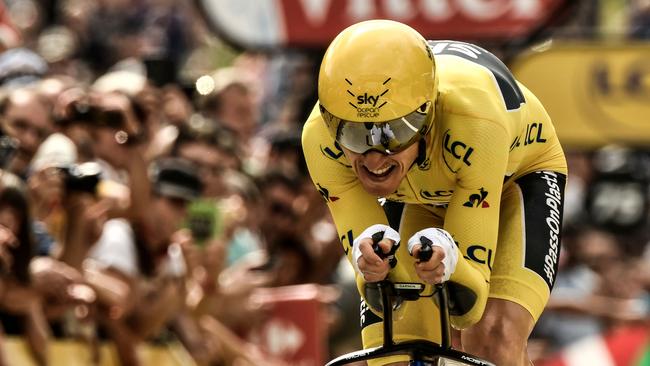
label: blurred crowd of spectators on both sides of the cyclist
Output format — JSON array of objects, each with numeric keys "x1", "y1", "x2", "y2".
[{"x1": 0, "y1": 0, "x2": 650, "y2": 365}]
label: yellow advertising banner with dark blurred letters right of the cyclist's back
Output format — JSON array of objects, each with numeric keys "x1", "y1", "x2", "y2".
[{"x1": 510, "y1": 44, "x2": 650, "y2": 148}]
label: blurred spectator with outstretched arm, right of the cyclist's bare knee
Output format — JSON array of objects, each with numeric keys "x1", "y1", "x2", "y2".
[{"x1": 536, "y1": 229, "x2": 650, "y2": 350}]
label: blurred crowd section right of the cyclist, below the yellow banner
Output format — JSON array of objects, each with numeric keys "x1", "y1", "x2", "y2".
[{"x1": 531, "y1": 145, "x2": 650, "y2": 359}]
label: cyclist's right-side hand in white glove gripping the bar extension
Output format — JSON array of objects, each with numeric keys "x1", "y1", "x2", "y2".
[{"x1": 408, "y1": 228, "x2": 458, "y2": 284}]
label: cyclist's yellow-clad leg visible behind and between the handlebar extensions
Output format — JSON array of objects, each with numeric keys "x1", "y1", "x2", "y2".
[{"x1": 361, "y1": 205, "x2": 442, "y2": 366}]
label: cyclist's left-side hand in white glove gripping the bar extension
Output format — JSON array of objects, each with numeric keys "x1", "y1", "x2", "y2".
[{"x1": 352, "y1": 224, "x2": 400, "y2": 282}]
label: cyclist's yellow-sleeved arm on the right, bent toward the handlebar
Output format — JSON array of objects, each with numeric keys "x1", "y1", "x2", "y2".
[{"x1": 444, "y1": 118, "x2": 509, "y2": 328}]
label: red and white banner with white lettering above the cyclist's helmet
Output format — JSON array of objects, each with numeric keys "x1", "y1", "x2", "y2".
[{"x1": 200, "y1": 0, "x2": 565, "y2": 48}]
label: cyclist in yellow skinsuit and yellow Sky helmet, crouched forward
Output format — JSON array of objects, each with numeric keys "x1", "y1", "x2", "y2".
[{"x1": 302, "y1": 20, "x2": 567, "y2": 366}]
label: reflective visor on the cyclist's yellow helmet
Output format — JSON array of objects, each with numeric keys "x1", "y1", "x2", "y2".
[{"x1": 320, "y1": 102, "x2": 433, "y2": 155}]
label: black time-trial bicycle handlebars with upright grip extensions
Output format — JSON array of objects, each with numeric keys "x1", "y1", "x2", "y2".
[{"x1": 325, "y1": 233, "x2": 495, "y2": 366}]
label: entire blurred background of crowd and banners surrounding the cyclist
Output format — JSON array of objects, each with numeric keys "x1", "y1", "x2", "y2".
[{"x1": 0, "y1": 0, "x2": 650, "y2": 366}]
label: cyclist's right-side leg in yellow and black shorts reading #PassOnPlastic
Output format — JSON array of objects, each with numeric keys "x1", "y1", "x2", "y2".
[{"x1": 462, "y1": 172, "x2": 566, "y2": 366}]
